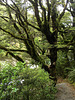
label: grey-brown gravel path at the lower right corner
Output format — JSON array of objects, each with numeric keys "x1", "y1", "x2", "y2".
[{"x1": 55, "y1": 78, "x2": 75, "y2": 100}]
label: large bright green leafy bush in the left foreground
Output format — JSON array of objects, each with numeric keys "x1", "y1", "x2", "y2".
[{"x1": 0, "y1": 62, "x2": 56, "y2": 100}]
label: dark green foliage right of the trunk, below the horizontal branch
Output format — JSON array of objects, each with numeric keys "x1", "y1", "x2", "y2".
[{"x1": 56, "y1": 51, "x2": 71, "y2": 78}]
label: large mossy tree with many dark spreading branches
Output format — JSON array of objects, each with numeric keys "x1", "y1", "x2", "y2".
[{"x1": 0, "y1": 0, "x2": 72, "y2": 81}]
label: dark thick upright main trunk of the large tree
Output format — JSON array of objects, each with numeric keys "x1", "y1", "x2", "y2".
[{"x1": 44, "y1": 27, "x2": 57, "y2": 84}]
